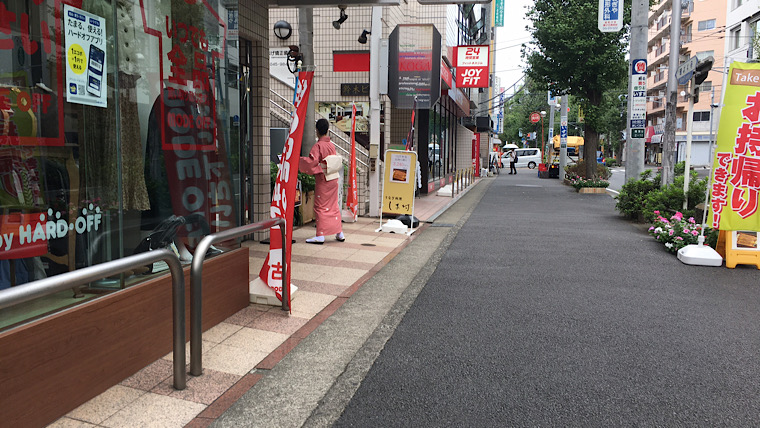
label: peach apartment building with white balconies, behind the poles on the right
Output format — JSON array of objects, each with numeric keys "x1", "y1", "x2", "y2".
[{"x1": 645, "y1": 0, "x2": 724, "y2": 166}]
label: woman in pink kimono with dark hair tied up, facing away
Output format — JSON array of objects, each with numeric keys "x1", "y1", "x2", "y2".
[{"x1": 298, "y1": 119, "x2": 346, "y2": 245}]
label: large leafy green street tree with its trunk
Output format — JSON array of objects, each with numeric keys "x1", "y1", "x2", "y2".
[{"x1": 522, "y1": 0, "x2": 630, "y2": 177}]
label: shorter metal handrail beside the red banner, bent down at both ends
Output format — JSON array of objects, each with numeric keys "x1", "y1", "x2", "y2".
[{"x1": 189, "y1": 217, "x2": 290, "y2": 376}]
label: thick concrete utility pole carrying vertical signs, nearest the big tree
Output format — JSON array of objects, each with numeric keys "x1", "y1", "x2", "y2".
[{"x1": 625, "y1": 0, "x2": 648, "y2": 182}]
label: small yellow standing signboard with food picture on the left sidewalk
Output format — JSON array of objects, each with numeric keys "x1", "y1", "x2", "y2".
[{"x1": 382, "y1": 150, "x2": 417, "y2": 215}]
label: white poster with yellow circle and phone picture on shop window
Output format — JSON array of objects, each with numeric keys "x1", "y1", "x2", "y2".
[{"x1": 63, "y1": 4, "x2": 108, "y2": 107}]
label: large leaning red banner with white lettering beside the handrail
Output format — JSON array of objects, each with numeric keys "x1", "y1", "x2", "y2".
[{"x1": 259, "y1": 71, "x2": 314, "y2": 305}]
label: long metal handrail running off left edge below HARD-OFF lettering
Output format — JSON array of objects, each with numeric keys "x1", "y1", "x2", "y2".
[{"x1": 0, "y1": 248, "x2": 187, "y2": 390}]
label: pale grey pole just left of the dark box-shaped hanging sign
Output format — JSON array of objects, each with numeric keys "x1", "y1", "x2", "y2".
[{"x1": 369, "y1": 6, "x2": 383, "y2": 217}]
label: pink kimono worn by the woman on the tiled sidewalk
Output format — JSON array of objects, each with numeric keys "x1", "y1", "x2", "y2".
[{"x1": 298, "y1": 136, "x2": 343, "y2": 236}]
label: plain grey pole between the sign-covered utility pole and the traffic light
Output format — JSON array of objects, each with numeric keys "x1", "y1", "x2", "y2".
[{"x1": 662, "y1": 0, "x2": 681, "y2": 186}]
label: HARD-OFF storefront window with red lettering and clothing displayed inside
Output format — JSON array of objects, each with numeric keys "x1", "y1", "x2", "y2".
[{"x1": 0, "y1": 0, "x2": 240, "y2": 328}]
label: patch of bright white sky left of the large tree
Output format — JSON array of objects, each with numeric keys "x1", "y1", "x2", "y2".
[{"x1": 493, "y1": 0, "x2": 533, "y2": 93}]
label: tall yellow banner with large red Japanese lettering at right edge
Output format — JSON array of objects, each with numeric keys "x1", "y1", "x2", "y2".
[{"x1": 709, "y1": 62, "x2": 760, "y2": 231}]
